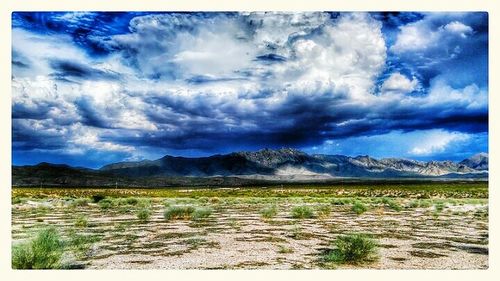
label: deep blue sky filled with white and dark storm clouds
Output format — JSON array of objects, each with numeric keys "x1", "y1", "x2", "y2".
[{"x1": 12, "y1": 12, "x2": 488, "y2": 168}]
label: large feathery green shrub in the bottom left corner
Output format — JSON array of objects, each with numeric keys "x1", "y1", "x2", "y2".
[{"x1": 12, "y1": 228, "x2": 63, "y2": 269}]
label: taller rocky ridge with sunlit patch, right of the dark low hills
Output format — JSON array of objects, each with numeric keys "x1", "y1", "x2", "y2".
[{"x1": 100, "y1": 148, "x2": 488, "y2": 178}]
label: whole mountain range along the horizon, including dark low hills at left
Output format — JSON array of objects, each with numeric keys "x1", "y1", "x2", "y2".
[{"x1": 12, "y1": 148, "x2": 488, "y2": 186}]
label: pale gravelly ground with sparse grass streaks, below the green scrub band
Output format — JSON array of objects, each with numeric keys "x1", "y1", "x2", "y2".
[{"x1": 12, "y1": 198, "x2": 488, "y2": 269}]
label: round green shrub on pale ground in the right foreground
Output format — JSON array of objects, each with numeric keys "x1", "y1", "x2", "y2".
[{"x1": 325, "y1": 233, "x2": 377, "y2": 264}]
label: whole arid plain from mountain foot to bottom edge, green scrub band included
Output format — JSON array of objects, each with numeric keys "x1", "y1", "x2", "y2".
[{"x1": 12, "y1": 183, "x2": 488, "y2": 269}]
